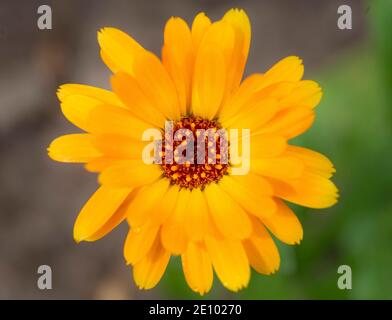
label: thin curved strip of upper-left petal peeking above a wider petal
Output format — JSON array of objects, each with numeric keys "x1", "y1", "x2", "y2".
[{"x1": 57, "y1": 83, "x2": 124, "y2": 107}]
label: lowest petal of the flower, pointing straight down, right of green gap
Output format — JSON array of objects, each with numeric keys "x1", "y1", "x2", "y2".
[{"x1": 181, "y1": 242, "x2": 214, "y2": 295}]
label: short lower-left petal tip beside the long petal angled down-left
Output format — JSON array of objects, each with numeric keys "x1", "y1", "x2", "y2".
[{"x1": 124, "y1": 221, "x2": 159, "y2": 265}]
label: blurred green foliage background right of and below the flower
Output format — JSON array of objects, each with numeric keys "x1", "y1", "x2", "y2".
[{"x1": 159, "y1": 0, "x2": 392, "y2": 299}]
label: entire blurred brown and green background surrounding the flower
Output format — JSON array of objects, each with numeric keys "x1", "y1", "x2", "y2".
[{"x1": 0, "y1": 0, "x2": 392, "y2": 299}]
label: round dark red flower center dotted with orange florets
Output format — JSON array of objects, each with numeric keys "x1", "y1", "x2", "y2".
[{"x1": 161, "y1": 116, "x2": 229, "y2": 190}]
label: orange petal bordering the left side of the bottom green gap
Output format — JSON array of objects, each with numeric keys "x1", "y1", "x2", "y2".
[{"x1": 133, "y1": 236, "x2": 170, "y2": 289}]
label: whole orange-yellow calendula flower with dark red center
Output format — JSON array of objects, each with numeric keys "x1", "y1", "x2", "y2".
[{"x1": 49, "y1": 10, "x2": 338, "y2": 294}]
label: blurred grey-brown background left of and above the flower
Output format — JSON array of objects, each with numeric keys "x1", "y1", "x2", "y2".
[{"x1": 0, "y1": 0, "x2": 367, "y2": 299}]
